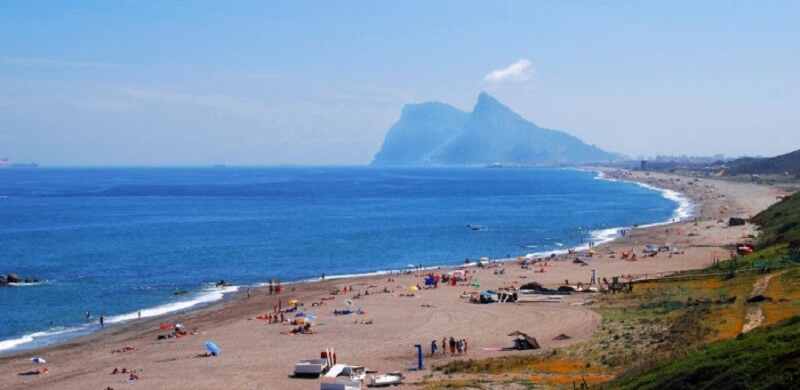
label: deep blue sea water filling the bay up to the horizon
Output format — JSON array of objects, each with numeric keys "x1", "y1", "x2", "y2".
[{"x1": 0, "y1": 167, "x2": 679, "y2": 353}]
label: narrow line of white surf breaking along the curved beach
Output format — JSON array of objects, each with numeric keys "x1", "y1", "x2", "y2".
[{"x1": 0, "y1": 167, "x2": 694, "y2": 358}]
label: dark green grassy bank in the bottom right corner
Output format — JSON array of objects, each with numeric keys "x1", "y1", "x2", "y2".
[{"x1": 606, "y1": 317, "x2": 800, "y2": 389}]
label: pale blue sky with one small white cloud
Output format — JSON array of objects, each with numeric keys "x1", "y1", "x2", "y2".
[{"x1": 0, "y1": 0, "x2": 800, "y2": 165}]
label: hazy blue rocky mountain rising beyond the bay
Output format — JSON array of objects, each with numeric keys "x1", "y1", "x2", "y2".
[{"x1": 372, "y1": 93, "x2": 617, "y2": 165}]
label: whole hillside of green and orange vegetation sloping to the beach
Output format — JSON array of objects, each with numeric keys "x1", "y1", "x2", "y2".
[{"x1": 423, "y1": 194, "x2": 800, "y2": 390}]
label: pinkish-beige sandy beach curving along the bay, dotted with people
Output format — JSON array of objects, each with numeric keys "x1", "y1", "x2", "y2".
[{"x1": 0, "y1": 174, "x2": 782, "y2": 390}]
